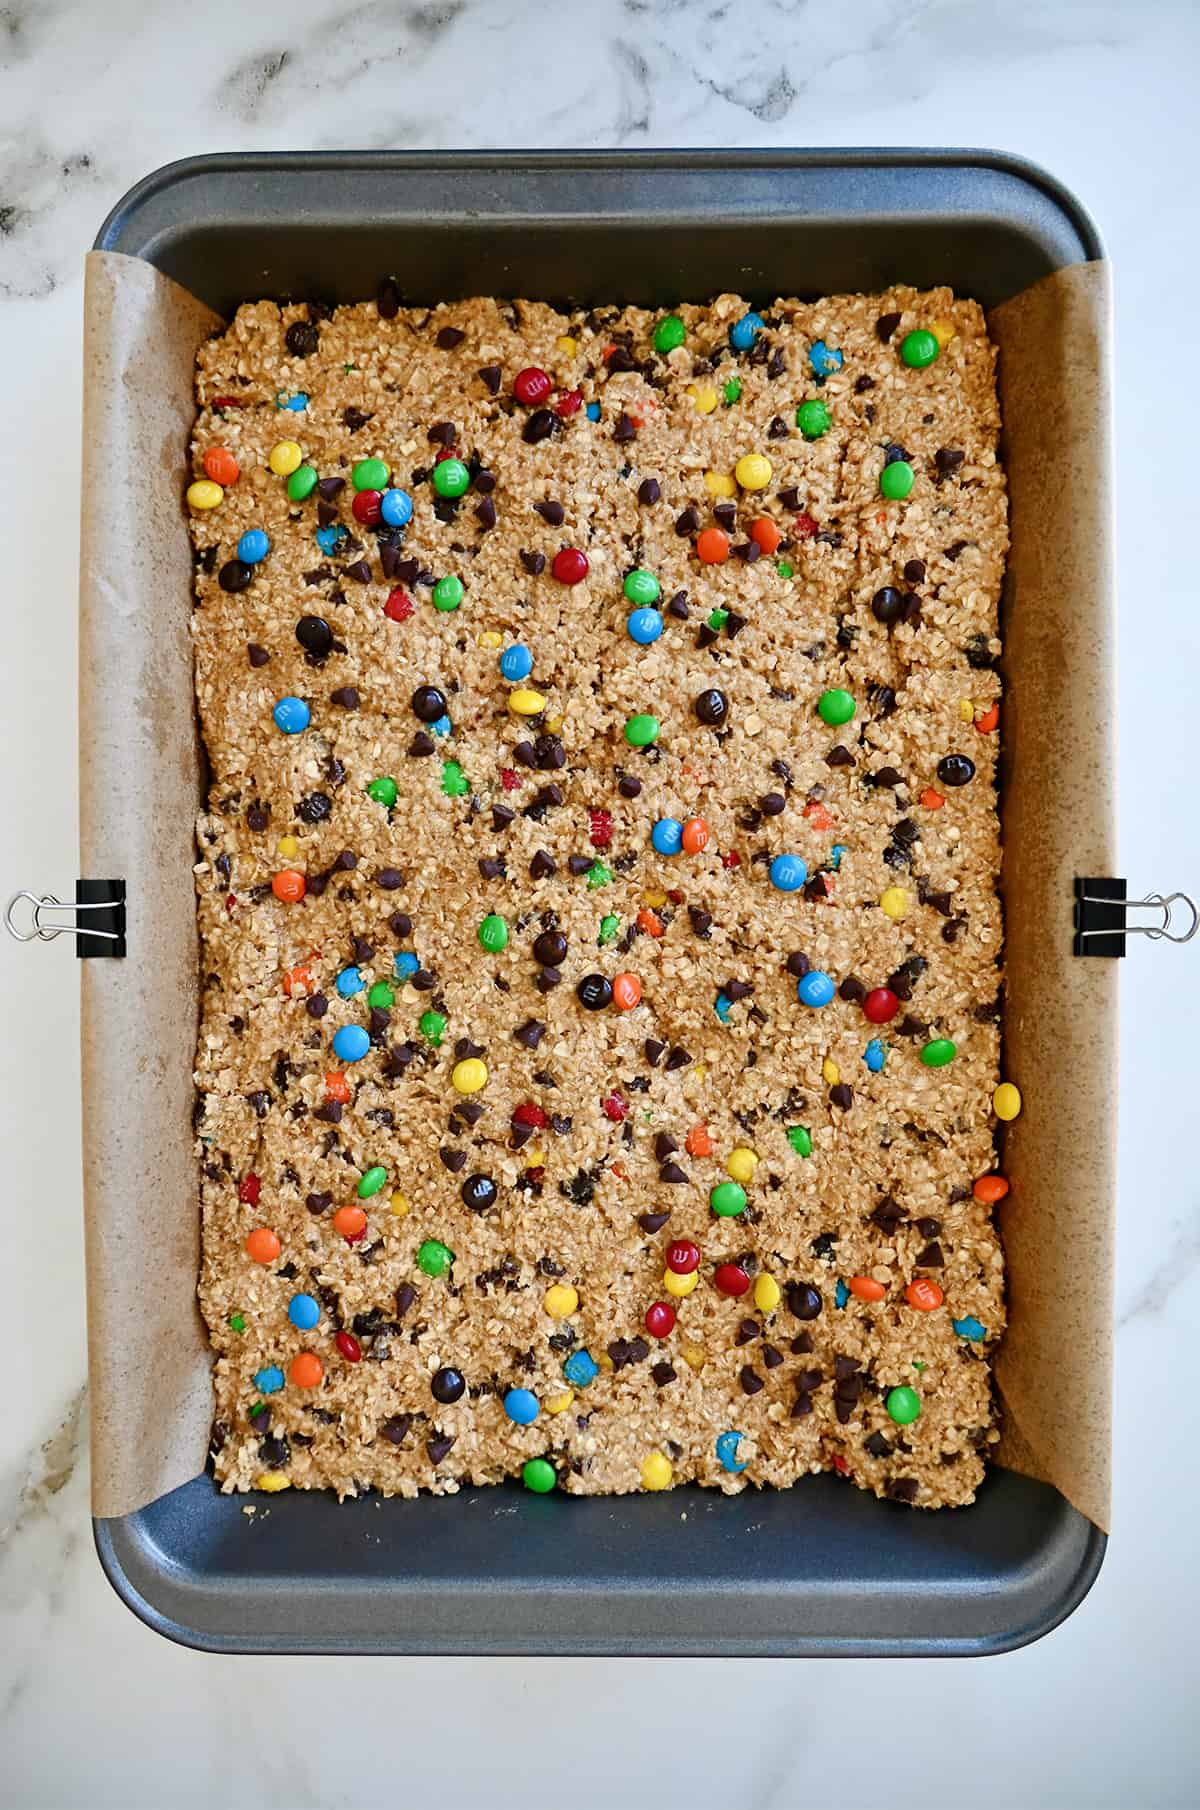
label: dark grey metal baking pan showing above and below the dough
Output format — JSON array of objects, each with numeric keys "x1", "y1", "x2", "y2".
[{"x1": 94, "y1": 150, "x2": 1106, "y2": 1656}]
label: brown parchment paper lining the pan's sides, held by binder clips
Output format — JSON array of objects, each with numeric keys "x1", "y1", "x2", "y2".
[{"x1": 80, "y1": 252, "x2": 1117, "y2": 1528}]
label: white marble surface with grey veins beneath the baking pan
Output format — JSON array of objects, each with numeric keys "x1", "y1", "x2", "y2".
[{"x1": 0, "y1": 0, "x2": 1200, "y2": 1810}]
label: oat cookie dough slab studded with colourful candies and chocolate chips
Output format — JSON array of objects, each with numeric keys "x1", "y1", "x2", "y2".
[{"x1": 188, "y1": 284, "x2": 1015, "y2": 1508}]
